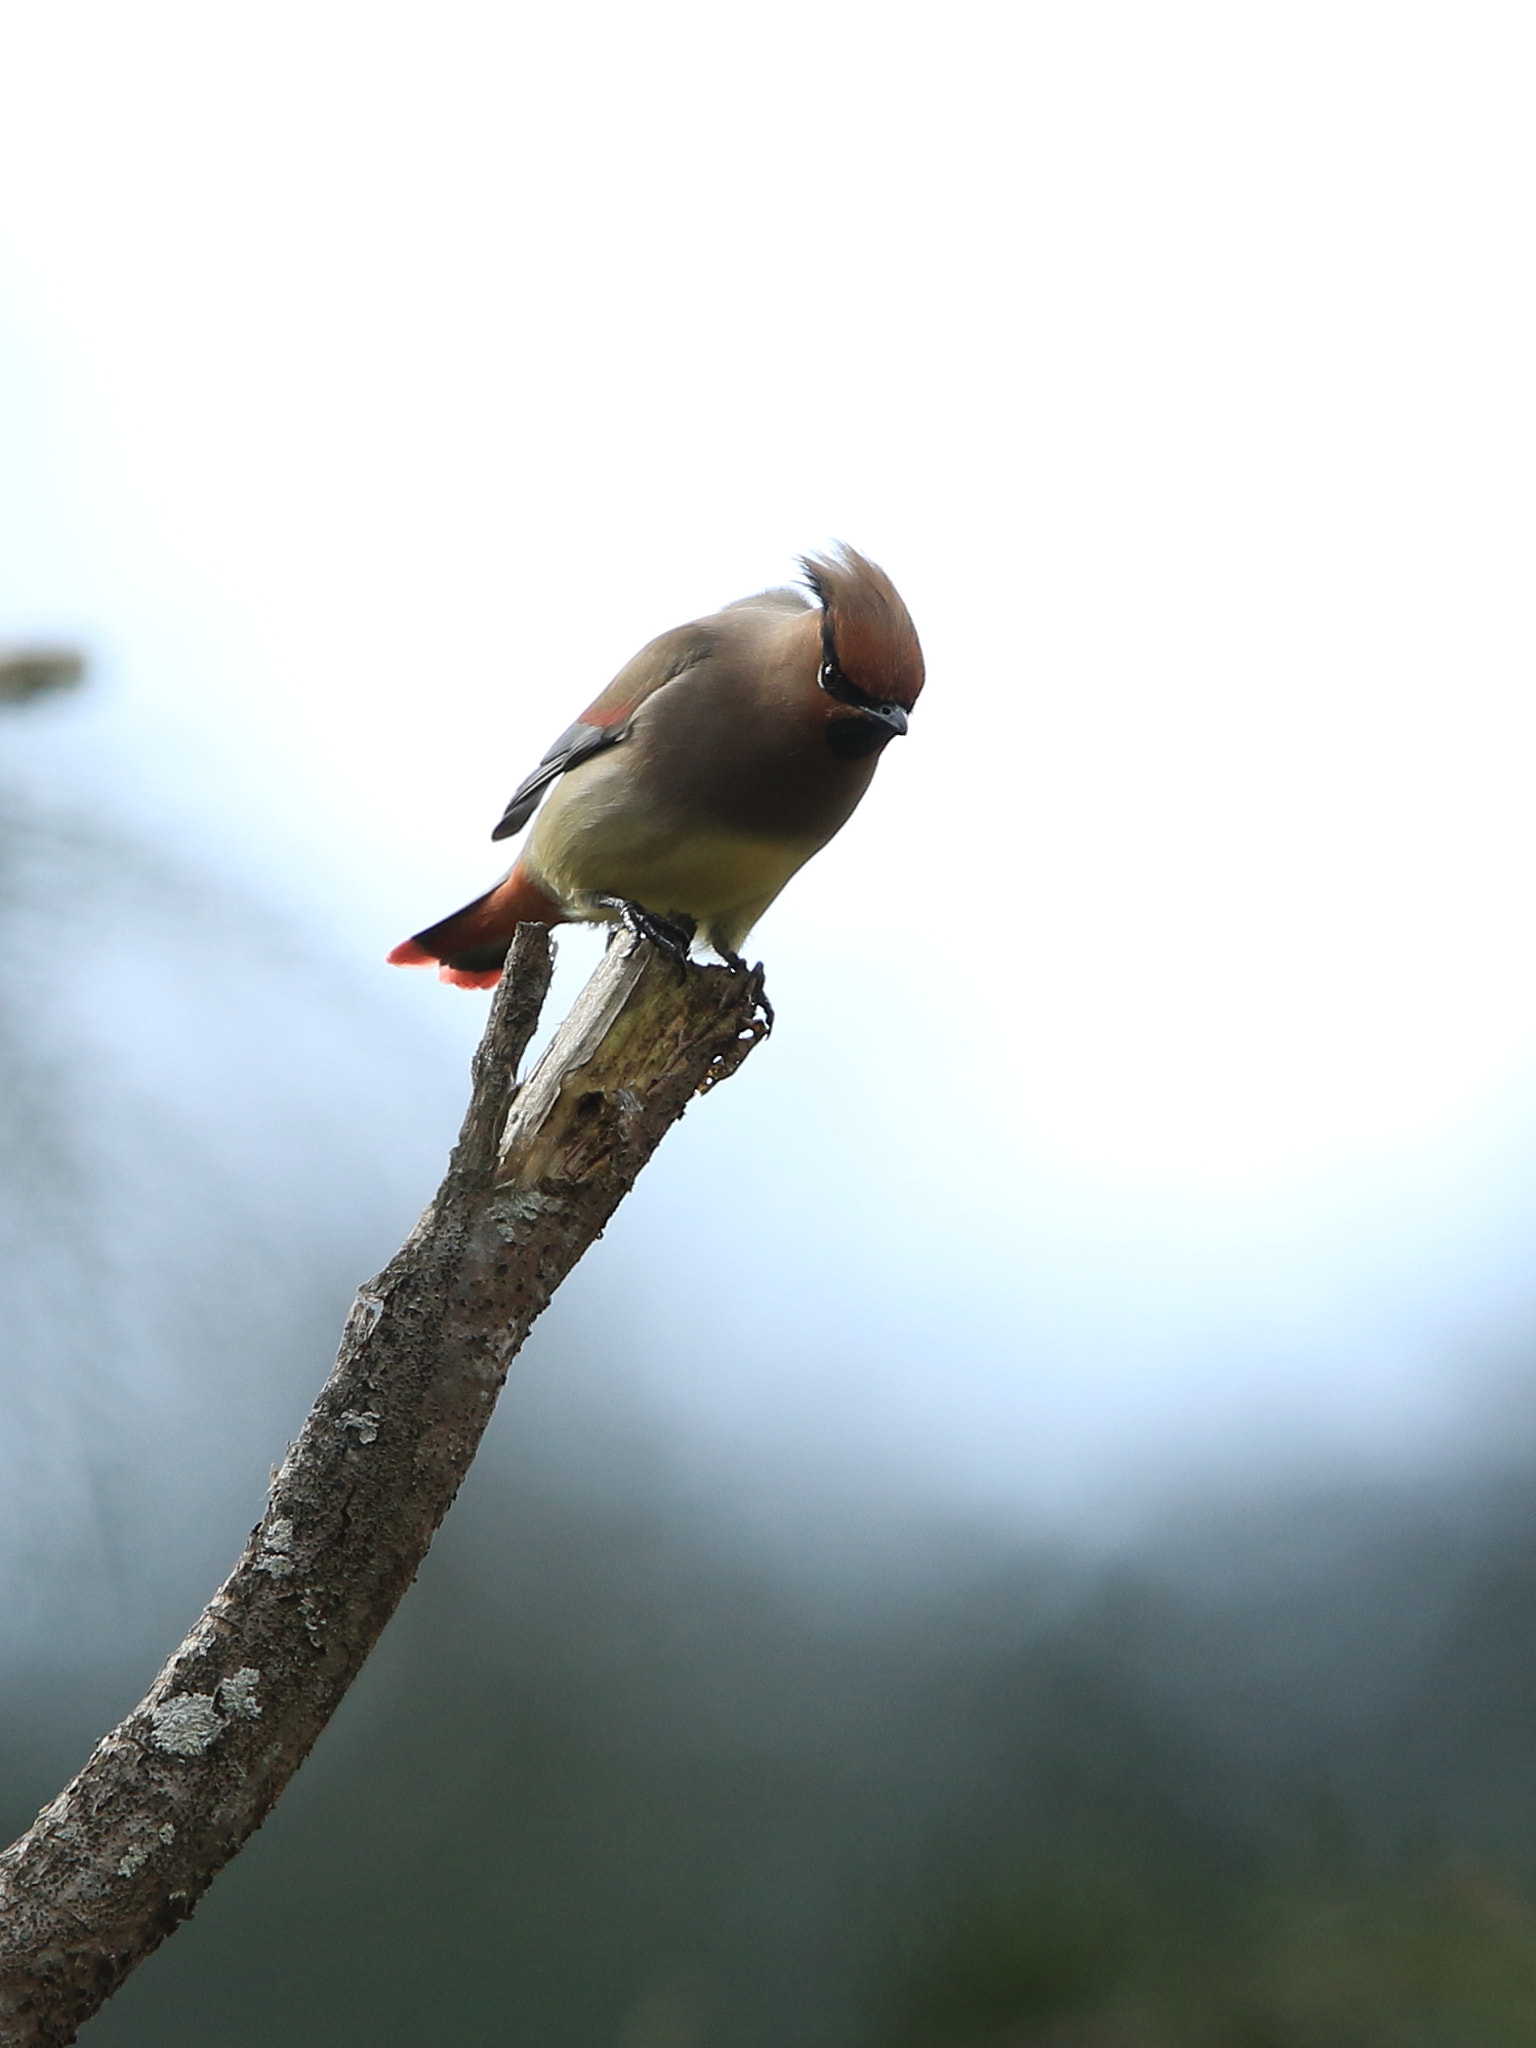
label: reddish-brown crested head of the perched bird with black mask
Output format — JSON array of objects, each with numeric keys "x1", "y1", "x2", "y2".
[{"x1": 801, "y1": 543, "x2": 924, "y2": 760}]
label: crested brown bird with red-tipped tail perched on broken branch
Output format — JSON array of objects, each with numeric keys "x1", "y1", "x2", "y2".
[{"x1": 389, "y1": 543, "x2": 924, "y2": 989}]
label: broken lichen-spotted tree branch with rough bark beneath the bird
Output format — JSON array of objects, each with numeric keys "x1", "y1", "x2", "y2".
[{"x1": 0, "y1": 926, "x2": 766, "y2": 2048}]
